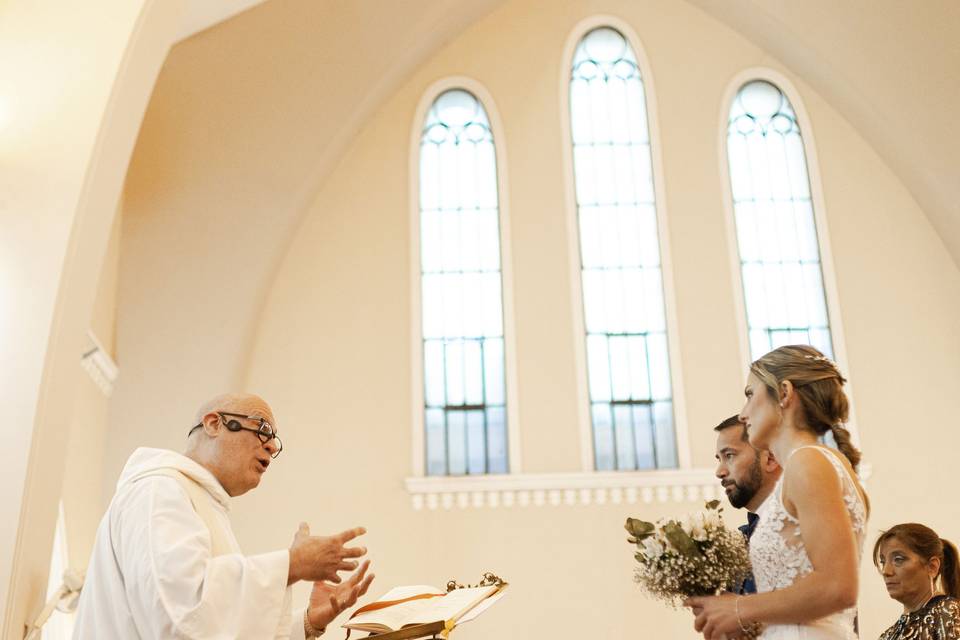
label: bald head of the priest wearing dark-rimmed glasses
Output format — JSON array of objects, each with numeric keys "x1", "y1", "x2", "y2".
[{"x1": 185, "y1": 393, "x2": 279, "y2": 496}]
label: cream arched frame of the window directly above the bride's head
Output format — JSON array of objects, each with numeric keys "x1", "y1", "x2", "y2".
[{"x1": 717, "y1": 67, "x2": 860, "y2": 447}]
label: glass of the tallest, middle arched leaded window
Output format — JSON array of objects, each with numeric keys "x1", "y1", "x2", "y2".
[{"x1": 570, "y1": 27, "x2": 677, "y2": 470}]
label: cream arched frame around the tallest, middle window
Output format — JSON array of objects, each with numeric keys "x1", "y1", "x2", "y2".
[{"x1": 559, "y1": 14, "x2": 692, "y2": 474}]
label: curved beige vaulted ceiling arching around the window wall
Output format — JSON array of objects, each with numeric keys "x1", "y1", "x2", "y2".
[{"x1": 114, "y1": 0, "x2": 960, "y2": 456}]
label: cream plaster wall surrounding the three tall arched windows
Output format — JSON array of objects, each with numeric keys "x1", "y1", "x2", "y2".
[{"x1": 227, "y1": 1, "x2": 960, "y2": 639}]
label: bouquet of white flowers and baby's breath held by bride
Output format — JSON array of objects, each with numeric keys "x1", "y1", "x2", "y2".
[{"x1": 625, "y1": 500, "x2": 750, "y2": 607}]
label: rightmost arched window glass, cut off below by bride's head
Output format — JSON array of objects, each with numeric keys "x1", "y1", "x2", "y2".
[{"x1": 727, "y1": 80, "x2": 833, "y2": 359}]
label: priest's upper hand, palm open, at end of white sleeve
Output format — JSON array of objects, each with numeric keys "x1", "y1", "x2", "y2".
[{"x1": 287, "y1": 522, "x2": 367, "y2": 585}]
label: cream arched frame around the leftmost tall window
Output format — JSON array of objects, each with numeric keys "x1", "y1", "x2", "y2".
[{"x1": 408, "y1": 76, "x2": 522, "y2": 481}]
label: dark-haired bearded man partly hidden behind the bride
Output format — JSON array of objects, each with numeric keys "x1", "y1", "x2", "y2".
[{"x1": 713, "y1": 416, "x2": 783, "y2": 594}]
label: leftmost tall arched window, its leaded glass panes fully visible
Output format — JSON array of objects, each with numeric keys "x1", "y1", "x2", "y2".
[{"x1": 420, "y1": 89, "x2": 508, "y2": 475}]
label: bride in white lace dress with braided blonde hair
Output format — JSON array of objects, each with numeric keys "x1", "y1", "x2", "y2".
[{"x1": 685, "y1": 345, "x2": 869, "y2": 640}]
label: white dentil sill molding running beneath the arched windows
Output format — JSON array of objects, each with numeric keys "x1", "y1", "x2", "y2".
[{"x1": 404, "y1": 464, "x2": 872, "y2": 511}]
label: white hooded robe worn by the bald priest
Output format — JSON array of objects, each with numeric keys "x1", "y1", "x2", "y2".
[{"x1": 73, "y1": 448, "x2": 304, "y2": 640}]
